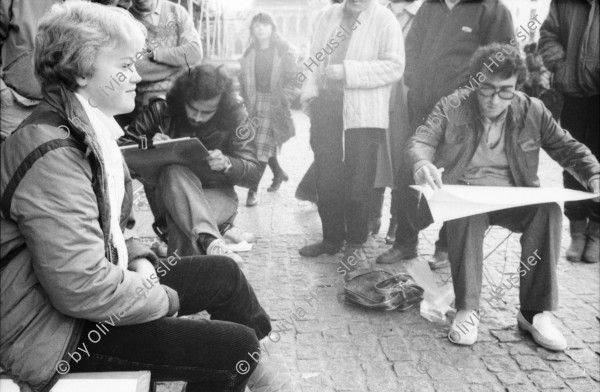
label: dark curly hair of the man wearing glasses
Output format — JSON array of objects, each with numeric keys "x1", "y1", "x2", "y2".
[{"x1": 469, "y1": 42, "x2": 527, "y2": 86}]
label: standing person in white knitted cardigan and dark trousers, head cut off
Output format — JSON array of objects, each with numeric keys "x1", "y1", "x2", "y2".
[{"x1": 298, "y1": 0, "x2": 404, "y2": 275}]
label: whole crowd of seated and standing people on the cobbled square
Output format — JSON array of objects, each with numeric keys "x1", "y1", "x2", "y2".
[{"x1": 0, "y1": 0, "x2": 600, "y2": 392}]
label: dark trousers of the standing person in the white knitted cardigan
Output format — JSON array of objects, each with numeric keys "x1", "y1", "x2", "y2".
[{"x1": 310, "y1": 97, "x2": 385, "y2": 245}]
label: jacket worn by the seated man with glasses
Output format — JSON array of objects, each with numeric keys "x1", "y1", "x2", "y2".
[{"x1": 405, "y1": 90, "x2": 600, "y2": 188}]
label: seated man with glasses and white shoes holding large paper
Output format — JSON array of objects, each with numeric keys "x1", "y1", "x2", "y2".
[{"x1": 405, "y1": 44, "x2": 600, "y2": 351}]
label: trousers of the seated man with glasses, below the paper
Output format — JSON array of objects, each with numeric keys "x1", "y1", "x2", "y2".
[{"x1": 446, "y1": 203, "x2": 562, "y2": 311}]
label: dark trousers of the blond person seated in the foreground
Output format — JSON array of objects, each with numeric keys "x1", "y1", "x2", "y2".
[{"x1": 71, "y1": 256, "x2": 271, "y2": 392}]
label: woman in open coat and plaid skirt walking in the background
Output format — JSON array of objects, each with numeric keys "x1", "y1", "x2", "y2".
[{"x1": 240, "y1": 13, "x2": 300, "y2": 206}]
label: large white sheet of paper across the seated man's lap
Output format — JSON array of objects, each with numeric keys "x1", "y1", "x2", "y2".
[{"x1": 411, "y1": 185, "x2": 598, "y2": 222}]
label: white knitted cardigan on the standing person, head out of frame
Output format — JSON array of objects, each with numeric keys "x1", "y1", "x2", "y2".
[{"x1": 301, "y1": 2, "x2": 405, "y2": 129}]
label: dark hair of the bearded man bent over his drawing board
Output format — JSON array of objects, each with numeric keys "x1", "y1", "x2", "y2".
[{"x1": 166, "y1": 64, "x2": 243, "y2": 128}]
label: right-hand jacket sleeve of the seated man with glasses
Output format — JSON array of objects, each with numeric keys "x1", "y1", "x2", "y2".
[{"x1": 532, "y1": 99, "x2": 600, "y2": 188}]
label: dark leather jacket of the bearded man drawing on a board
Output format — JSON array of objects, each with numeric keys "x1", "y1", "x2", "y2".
[{"x1": 120, "y1": 99, "x2": 259, "y2": 188}]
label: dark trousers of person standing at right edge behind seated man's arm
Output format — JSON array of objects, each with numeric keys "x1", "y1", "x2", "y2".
[{"x1": 560, "y1": 95, "x2": 600, "y2": 222}]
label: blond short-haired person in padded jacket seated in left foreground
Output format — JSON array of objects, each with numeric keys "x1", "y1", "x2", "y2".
[{"x1": 0, "y1": 2, "x2": 271, "y2": 392}]
